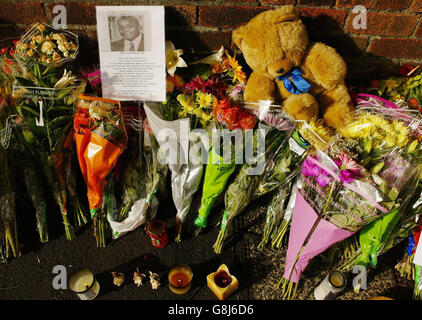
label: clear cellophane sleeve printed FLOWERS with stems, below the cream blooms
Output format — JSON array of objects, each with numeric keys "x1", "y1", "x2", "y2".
[{"x1": 13, "y1": 72, "x2": 85, "y2": 241}]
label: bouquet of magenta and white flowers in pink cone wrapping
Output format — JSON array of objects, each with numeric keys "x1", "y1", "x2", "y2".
[{"x1": 284, "y1": 144, "x2": 415, "y2": 283}]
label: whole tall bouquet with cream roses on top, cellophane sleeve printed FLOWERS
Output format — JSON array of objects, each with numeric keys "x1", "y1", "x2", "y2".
[{"x1": 13, "y1": 24, "x2": 85, "y2": 241}]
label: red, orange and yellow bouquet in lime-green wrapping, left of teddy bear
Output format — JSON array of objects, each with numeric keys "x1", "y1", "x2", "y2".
[{"x1": 183, "y1": 47, "x2": 257, "y2": 233}]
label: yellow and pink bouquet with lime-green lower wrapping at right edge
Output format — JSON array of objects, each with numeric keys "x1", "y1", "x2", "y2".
[{"x1": 339, "y1": 94, "x2": 421, "y2": 270}]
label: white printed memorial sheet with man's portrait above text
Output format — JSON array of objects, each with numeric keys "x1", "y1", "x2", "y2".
[{"x1": 96, "y1": 6, "x2": 166, "y2": 101}]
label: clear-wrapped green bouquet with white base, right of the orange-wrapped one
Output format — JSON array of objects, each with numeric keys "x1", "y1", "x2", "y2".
[{"x1": 105, "y1": 106, "x2": 167, "y2": 239}]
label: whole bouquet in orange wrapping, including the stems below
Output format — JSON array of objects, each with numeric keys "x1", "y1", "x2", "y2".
[{"x1": 73, "y1": 95, "x2": 127, "y2": 246}]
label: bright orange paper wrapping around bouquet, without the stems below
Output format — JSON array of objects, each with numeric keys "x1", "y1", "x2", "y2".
[{"x1": 74, "y1": 96, "x2": 127, "y2": 213}]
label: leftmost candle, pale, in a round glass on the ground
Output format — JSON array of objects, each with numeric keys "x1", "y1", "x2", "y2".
[{"x1": 69, "y1": 269, "x2": 100, "y2": 300}]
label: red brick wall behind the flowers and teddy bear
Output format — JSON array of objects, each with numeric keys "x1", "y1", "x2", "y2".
[{"x1": 0, "y1": 0, "x2": 422, "y2": 81}]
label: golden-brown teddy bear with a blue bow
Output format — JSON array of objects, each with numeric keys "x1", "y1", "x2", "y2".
[{"x1": 232, "y1": 5, "x2": 354, "y2": 128}]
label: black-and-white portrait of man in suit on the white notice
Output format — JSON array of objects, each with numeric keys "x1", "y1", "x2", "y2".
[{"x1": 108, "y1": 14, "x2": 147, "y2": 52}]
